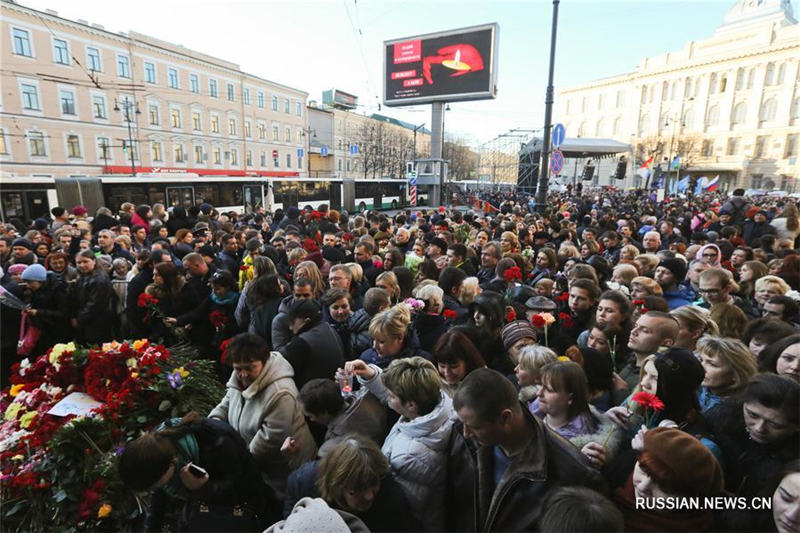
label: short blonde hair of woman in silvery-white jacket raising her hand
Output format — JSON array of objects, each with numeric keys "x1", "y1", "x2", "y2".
[{"x1": 381, "y1": 356, "x2": 442, "y2": 415}]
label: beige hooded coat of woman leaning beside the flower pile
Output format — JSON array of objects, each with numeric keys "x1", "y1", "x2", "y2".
[{"x1": 208, "y1": 352, "x2": 317, "y2": 500}]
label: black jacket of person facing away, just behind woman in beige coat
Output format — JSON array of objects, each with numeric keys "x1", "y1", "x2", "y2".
[{"x1": 280, "y1": 320, "x2": 344, "y2": 389}]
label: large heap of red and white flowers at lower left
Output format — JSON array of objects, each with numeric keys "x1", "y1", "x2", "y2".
[{"x1": 0, "y1": 340, "x2": 224, "y2": 531}]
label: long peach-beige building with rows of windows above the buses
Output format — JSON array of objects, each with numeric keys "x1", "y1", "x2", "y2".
[{"x1": 0, "y1": 0, "x2": 308, "y2": 182}]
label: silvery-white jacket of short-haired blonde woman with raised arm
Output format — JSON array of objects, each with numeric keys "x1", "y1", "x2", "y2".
[{"x1": 359, "y1": 365, "x2": 456, "y2": 531}]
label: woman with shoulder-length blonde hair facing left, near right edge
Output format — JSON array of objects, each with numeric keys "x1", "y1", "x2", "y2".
[{"x1": 697, "y1": 336, "x2": 758, "y2": 413}]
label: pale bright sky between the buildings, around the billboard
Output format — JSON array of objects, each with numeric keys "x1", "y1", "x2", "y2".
[{"x1": 19, "y1": 0, "x2": 796, "y2": 143}]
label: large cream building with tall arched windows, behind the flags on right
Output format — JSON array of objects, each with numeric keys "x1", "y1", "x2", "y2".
[{"x1": 555, "y1": 0, "x2": 800, "y2": 192}]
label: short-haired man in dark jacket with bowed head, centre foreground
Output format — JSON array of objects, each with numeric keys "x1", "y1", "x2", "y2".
[{"x1": 453, "y1": 368, "x2": 603, "y2": 532}]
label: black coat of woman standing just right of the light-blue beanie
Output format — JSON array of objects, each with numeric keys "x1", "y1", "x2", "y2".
[{"x1": 71, "y1": 268, "x2": 115, "y2": 344}]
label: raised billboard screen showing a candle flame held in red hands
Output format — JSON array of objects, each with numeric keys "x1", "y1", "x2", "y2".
[{"x1": 383, "y1": 24, "x2": 498, "y2": 106}]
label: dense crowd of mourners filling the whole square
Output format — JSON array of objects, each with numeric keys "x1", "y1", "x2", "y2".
[{"x1": 0, "y1": 190, "x2": 800, "y2": 533}]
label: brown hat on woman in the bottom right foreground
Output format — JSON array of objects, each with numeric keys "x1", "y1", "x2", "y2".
[{"x1": 644, "y1": 427, "x2": 723, "y2": 496}]
